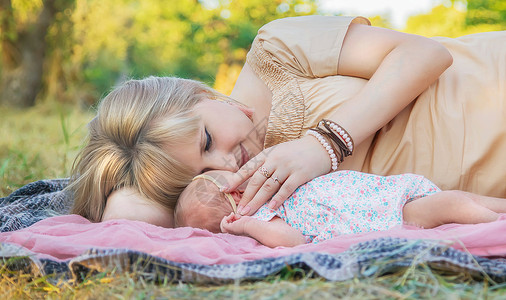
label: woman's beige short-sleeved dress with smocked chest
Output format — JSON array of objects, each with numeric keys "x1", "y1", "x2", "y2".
[{"x1": 247, "y1": 16, "x2": 506, "y2": 197}]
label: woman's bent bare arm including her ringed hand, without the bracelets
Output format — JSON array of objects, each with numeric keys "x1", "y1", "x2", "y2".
[{"x1": 223, "y1": 24, "x2": 452, "y2": 214}]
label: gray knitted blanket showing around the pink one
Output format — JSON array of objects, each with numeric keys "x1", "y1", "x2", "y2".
[{"x1": 0, "y1": 179, "x2": 506, "y2": 283}]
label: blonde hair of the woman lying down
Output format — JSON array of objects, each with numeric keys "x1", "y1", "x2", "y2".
[{"x1": 68, "y1": 77, "x2": 223, "y2": 222}]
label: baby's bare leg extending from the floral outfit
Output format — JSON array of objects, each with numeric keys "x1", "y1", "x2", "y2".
[{"x1": 403, "y1": 191, "x2": 498, "y2": 228}]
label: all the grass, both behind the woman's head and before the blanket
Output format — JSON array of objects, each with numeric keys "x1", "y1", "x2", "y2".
[{"x1": 0, "y1": 104, "x2": 506, "y2": 300}]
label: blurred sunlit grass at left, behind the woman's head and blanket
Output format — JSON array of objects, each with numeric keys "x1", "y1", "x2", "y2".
[{"x1": 0, "y1": 104, "x2": 93, "y2": 197}]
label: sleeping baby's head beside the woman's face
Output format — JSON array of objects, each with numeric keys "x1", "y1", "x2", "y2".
[{"x1": 174, "y1": 170, "x2": 242, "y2": 233}]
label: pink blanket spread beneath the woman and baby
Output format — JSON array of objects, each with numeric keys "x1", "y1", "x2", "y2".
[{"x1": 0, "y1": 215, "x2": 506, "y2": 265}]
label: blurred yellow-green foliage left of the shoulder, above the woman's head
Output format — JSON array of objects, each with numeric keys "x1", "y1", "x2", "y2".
[{"x1": 45, "y1": 0, "x2": 317, "y2": 104}]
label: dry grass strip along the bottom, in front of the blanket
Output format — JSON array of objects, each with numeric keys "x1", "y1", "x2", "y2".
[{"x1": 0, "y1": 266, "x2": 506, "y2": 299}]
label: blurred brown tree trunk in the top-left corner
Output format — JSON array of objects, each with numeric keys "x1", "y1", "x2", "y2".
[{"x1": 0, "y1": 0, "x2": 55, "y2": 107}]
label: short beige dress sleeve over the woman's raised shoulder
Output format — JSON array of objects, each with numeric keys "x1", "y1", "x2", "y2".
[{"x1": 246, "y1": 15, "x2": 370, "y2": 80}]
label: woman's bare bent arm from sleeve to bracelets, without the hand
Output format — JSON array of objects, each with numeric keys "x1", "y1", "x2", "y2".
[{"x1": 329, "y1": 24, "x2": 453, "y2": 144}]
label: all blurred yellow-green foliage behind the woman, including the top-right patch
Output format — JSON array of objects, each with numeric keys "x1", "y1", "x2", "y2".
[{"x1": 0, "y1": 0, "x2": 506, "y2": 105}]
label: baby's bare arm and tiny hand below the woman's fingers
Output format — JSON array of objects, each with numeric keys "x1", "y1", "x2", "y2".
[{"x1": 220, "y1": 213, "x2": 306, "y2": 248}]
